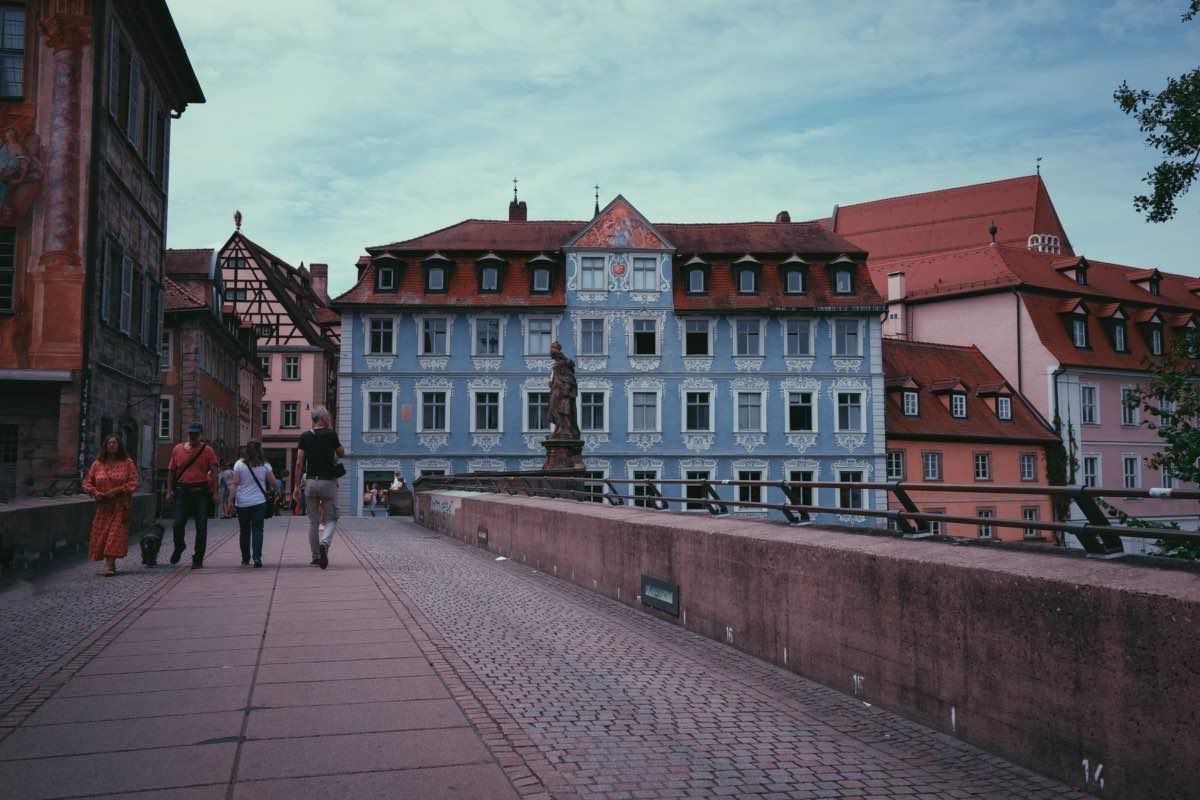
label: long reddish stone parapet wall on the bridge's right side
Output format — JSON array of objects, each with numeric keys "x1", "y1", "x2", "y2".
[{"x1": 416, "y1": 492, "x2": 1200, "y2": 799}]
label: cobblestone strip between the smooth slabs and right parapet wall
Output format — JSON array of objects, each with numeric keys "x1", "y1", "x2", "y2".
[{"x1": 343, "y1": 519, "x2": 1086, "y2": 800}]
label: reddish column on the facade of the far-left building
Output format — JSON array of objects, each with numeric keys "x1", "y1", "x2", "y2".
[{"x1": 41, "y1": 13, "x2": 95, "y2": 266}]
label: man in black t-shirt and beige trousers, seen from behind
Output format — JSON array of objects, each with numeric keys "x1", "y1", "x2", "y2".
[{"x1": 292, "y1": 405, "x2": 346, "y2": 570}]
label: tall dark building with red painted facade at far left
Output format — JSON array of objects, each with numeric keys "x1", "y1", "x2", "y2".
[{"x1": 0, "y1": 0, "x2": 204, "y2": 497}]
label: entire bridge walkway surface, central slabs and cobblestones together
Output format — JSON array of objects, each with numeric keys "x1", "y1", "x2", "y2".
[{"x1": 0, "y1": 518, "x2": 1084, "y2": 799}]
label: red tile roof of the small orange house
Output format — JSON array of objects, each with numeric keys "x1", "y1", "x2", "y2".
[{"x1": 883, "y1": 339, "x2": 1057, "y2": 444}]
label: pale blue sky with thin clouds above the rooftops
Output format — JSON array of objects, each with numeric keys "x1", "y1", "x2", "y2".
[{"x1": 168, "y1": 0, "x2": 1200, "y2": 295}]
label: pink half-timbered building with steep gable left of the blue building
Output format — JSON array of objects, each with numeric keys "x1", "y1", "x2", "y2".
[{"x1": 217, "y1": 225, "x2": 341, "y2": 494}]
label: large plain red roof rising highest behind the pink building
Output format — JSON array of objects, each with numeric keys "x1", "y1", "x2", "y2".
[{"x1": 820, "y1": 175, "x2": 1074, "y2": 264}]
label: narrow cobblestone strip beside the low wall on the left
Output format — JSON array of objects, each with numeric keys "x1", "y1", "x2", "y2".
[{"x1": 0, "y1": 519, "x2": 233, "y2": 705}]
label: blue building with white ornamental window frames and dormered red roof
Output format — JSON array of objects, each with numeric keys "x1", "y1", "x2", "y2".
[{"x1": 332, "y1": 197, "x2": 886, "y2": 523}]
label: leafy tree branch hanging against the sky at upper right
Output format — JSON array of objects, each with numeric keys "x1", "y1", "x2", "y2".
[{"x1": 1112, "y1": 0, "x2": 1200, "y2": 222}]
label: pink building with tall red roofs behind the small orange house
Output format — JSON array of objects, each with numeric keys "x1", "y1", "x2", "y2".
[{"x1": 836, "y1": 176, "x2": 1200, "y2": 549}]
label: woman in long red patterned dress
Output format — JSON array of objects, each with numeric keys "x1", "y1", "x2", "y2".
[{"x1": 83, "y1": 435, "x2": 138, "y2": 578}]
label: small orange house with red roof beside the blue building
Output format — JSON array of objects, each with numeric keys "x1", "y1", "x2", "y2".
[{"x1": 883, "y1": 339, "x2": 1058, "y2": 541}]
